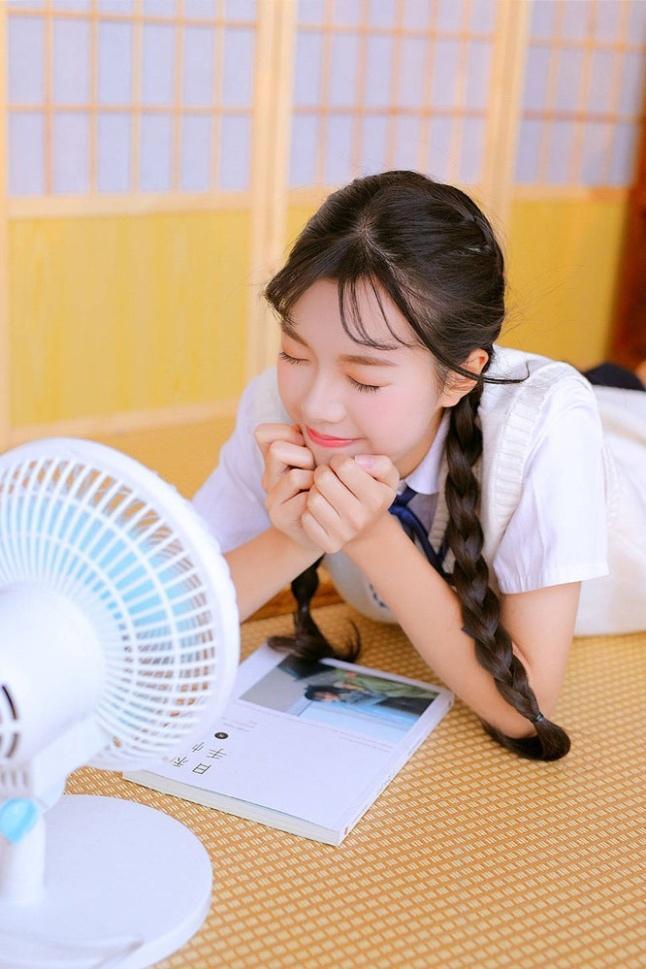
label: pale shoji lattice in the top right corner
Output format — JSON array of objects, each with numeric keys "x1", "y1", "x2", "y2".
[{"x1": 515, "y1": 0, "x2": 646, "y2": 192}]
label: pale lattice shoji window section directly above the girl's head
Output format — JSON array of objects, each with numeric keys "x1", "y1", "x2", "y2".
[{"x1": 290, "y1": 0, "x2": 524, "y2": 216}]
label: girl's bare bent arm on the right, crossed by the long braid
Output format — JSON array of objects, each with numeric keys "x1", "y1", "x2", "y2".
[{"x1": 344, "y1": 515, "x2": 581, "y2": 737}]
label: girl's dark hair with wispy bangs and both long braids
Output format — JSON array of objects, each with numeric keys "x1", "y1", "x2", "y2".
[{"x1": 265, "y1": 171, "x2": 570, "y2": 760}]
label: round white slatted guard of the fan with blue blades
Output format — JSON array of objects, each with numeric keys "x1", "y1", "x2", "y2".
[{"x1": 0, "y1": 438, "x2": 239, "y2": 770}]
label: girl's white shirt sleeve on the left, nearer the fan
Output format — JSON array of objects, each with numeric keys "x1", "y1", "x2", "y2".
[{"x1": 192, "y1": 378, "x2": 271, "y2": 552}]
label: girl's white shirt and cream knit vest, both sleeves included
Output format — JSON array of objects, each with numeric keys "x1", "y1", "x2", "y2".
[{"x1": 193, "y1": 346, "x2": 646, "y2": 635}]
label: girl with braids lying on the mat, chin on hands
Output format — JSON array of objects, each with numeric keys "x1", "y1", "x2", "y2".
[{"x1": 194, "y1": 171, "x2": 646, "y2": 760}]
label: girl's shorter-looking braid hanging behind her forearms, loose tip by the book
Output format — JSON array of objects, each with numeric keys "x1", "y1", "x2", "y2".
[{"x1": 267, "y1": 556, "x2": 361, "y2": 663}]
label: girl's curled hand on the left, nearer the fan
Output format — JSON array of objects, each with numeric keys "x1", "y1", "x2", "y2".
[{"x1": 254, "y1": 424, "x2": 323, "y2": 555}]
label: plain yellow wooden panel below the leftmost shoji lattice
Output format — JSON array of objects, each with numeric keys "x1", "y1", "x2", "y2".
[{"x1": 9, "y1": 211, "x2": 250, "y2": 427}]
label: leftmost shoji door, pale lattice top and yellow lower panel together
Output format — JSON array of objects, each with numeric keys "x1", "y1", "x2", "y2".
[{"x1": 0, "y1": 0, "x2": 266, "y2": 458}]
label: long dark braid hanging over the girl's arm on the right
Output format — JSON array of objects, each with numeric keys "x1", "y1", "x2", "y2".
[{"x1": 446, "y1": 390, "x2": 570, "y2": 760}]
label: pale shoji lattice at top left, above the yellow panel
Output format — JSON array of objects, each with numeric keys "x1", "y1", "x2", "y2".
[{"x1": 7, "y1": 0, "x2": 256, "y2": 200}]
